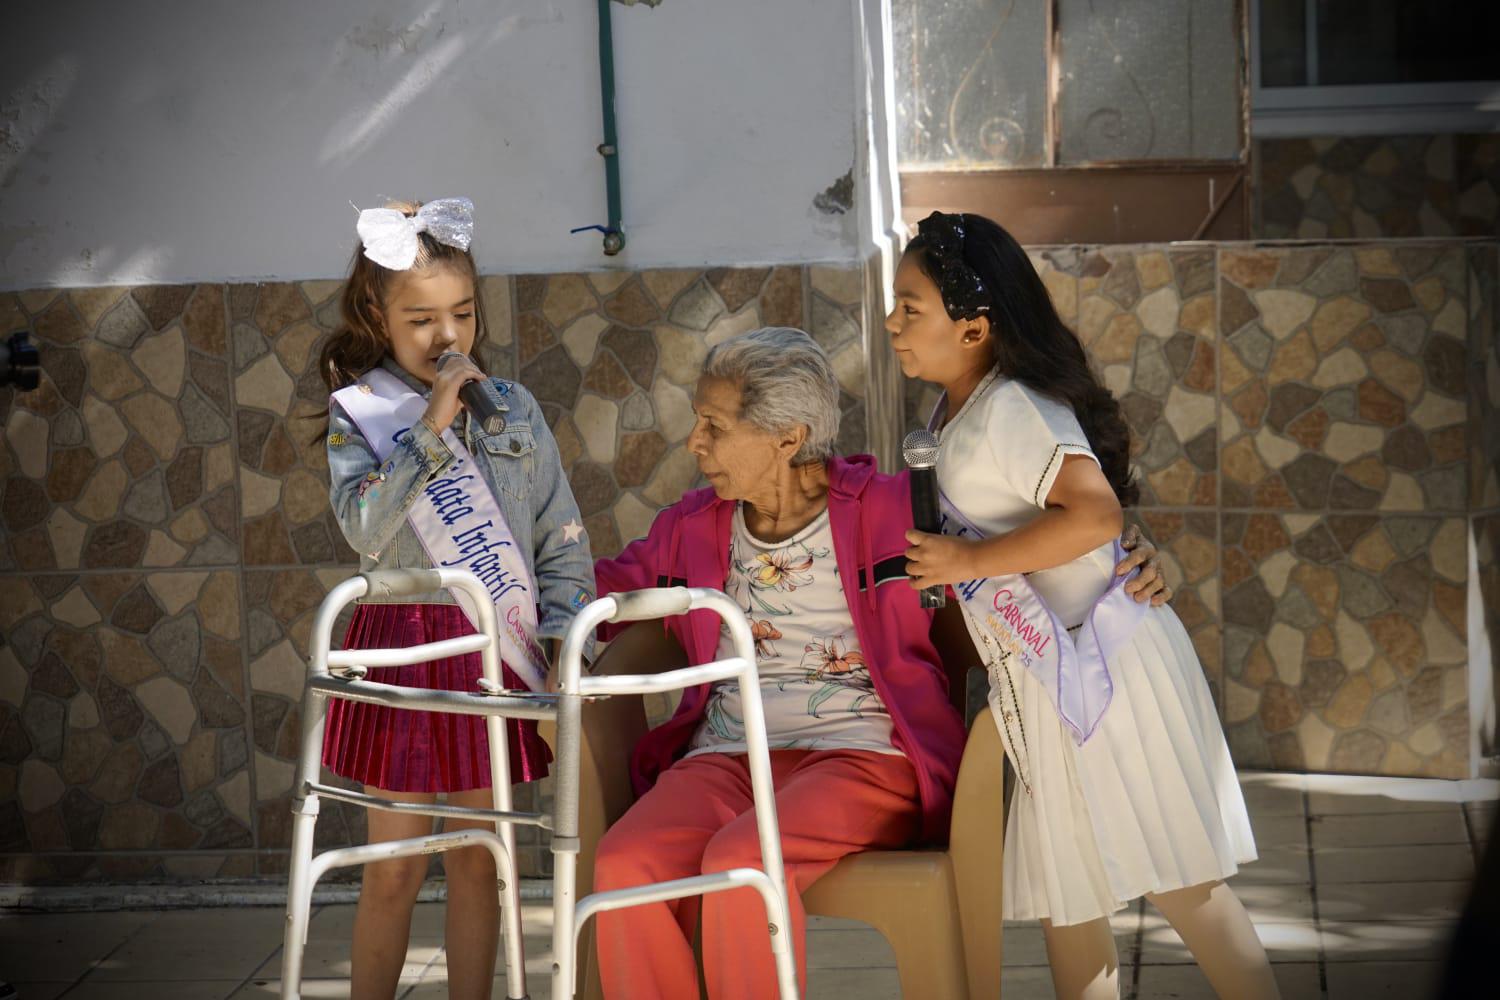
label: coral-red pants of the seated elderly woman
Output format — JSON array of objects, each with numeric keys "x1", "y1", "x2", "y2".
[{"x1": 594, "y1": 750, "x2": 921, "y2": 1000}]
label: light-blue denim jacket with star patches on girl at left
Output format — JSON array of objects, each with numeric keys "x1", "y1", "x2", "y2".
[{"x1": 329, "y1": 355, "x2": 594, "y2": 655}]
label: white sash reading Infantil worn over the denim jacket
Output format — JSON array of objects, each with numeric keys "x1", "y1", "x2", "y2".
[{"x1": 333, "y1": 369, "x2": 548, "y2": 691}]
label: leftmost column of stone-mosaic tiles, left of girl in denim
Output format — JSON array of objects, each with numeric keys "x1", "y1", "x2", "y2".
[{"x1": 0, "y1": 285, "x2": 257, "y2": 879}]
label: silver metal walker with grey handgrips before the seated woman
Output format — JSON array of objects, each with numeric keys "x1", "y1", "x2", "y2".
[{"x1": 281, "y1": 570, "x2": 797, "y2": 1000}]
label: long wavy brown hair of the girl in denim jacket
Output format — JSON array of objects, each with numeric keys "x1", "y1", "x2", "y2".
[{"x1": 318, "y1": 201, "x2": 489, "y2": 393}]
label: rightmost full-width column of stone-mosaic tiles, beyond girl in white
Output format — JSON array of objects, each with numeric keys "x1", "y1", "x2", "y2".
[{"x1": 1220, "y1": 246, "x2": 1469, "y2": 777}]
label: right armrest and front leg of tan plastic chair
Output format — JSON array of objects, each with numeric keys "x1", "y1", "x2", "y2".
[{"x1": 948, "y1": 708, "x2": 1005, "y2": 997}]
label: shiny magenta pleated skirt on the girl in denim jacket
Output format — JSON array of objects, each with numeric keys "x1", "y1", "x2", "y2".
[{"x1": 323, "y1": 604, "x2": 552, "y2": 792}]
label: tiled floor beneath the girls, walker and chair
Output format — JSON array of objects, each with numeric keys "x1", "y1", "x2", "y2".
[{"x1": 0, "y1": 774, "x2": 1500, "y2": 1000}]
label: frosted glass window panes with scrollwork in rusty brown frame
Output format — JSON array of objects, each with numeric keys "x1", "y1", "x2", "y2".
[{"x1": 891, "y1": 0, "x2": 1245, "y2": 171}]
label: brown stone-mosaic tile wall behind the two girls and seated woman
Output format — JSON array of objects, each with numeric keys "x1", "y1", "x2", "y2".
[{"x1": 0, "y1": 243, "x2": 1500, "y2": 880}]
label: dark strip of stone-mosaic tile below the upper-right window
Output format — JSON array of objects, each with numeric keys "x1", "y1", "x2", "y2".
[{"x1": 1256, "y1": 135, "x2": 1500, "y2": 240}]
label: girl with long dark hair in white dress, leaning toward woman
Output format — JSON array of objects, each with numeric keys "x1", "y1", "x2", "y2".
[{"x1": 887, "y1": 213, "x2": 1277, "y2": 999}]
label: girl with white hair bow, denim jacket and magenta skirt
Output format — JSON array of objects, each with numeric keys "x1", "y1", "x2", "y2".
[{"x1": 320, "y1": 198, "x2": 594, "y2": 999}]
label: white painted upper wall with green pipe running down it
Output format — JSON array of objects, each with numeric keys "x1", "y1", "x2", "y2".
[{"x1": 0, "y1": 0, "x2": 861, "y2": 289}]
